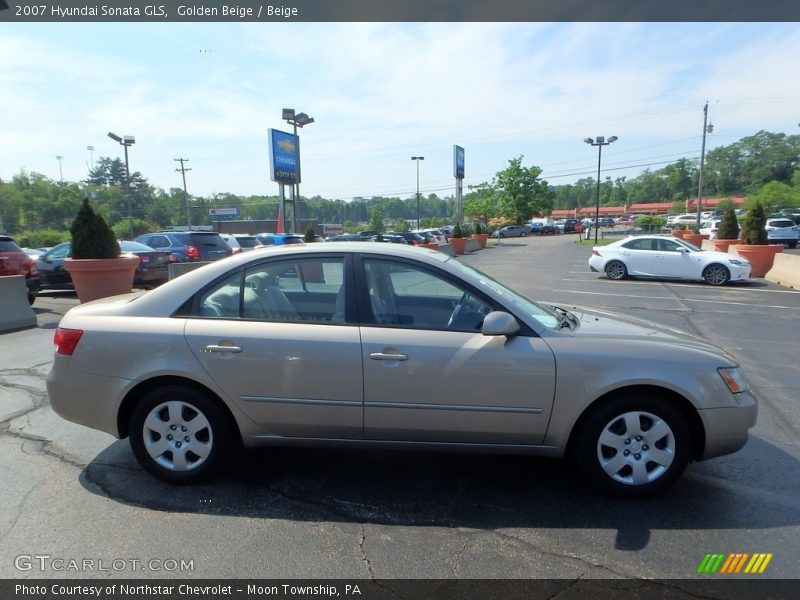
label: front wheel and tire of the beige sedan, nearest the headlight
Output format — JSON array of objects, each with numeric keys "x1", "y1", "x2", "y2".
[{"x1": 574, "y1": 393, "x2": 692, "y2": 497}]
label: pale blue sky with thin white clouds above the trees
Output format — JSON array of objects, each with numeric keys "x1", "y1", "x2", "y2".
[{"x1": 0, "y1": 23, "x2": 800, "y2": 199}]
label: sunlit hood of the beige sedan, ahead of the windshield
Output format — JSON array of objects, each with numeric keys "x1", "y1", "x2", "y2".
[{"x1": 562, "y1": 307, "x2": 737, "y2": 364}]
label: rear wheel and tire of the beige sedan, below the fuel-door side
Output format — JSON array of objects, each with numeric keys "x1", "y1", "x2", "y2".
[{"x1": 129, "y1": 386, "x2": 238, "y2": 484}]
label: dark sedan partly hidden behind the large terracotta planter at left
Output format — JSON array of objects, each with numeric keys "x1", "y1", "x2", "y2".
[{"x1": 36, "y1": 240, "x2": 175, "y2": 290}]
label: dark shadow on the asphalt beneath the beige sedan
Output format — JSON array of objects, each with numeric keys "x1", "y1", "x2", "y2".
[{"x1": 80, "y1": 437, "x2": 800, "y2": 551}]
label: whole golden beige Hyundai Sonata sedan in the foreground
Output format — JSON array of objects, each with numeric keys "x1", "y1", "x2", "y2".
[{"x1": 47, "y1": 243, "x2": 757, "y2": 495}]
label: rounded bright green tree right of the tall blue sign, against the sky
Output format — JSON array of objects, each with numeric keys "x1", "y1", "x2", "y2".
[{"x1": 494, "y1": 156, "x2": 554, "y2": 223}]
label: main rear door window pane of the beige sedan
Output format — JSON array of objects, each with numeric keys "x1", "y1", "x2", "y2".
[{"x1": 243, "y1": 257, "x2": 346, "y2": 324}]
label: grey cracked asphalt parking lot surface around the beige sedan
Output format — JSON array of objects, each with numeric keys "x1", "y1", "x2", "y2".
[{"x1": 0, "y1": 236, "x2": 800, "y2": 579}]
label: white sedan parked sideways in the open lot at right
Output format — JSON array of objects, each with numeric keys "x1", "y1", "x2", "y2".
[{"x1": 589, "y1": 235, "x2": 750, "y2": 285}]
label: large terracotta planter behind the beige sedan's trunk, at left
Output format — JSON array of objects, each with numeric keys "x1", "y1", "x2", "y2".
[{"x1": 64, "y1": 256, "x2": 139, "y2": 302}]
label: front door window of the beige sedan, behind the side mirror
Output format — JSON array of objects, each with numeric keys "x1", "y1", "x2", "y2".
[{"x1": 364, "y1": 259, "x2": 492, "y2": 331}]
